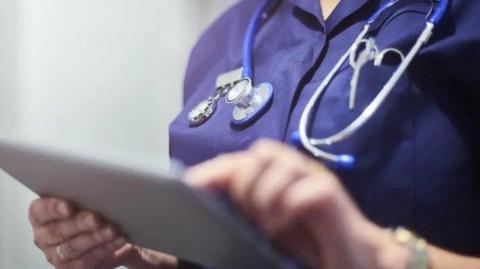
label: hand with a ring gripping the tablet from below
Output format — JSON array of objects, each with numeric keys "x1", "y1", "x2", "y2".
[{"x1": 29, "y1": 198, "x2": 176, "y2": 269}]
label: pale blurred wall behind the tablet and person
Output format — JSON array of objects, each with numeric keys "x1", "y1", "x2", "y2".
[{"x1": 0, "y1": 0, "x2": 234, "y2": 269}]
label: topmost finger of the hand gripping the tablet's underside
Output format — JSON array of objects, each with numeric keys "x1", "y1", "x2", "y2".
[{"x1": 28, "y1": 198, "x2": 74, "y2": 226}]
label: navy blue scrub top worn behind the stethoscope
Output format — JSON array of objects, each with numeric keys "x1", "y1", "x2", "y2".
[{"x1": 170, "y1": 0, "x2": 480, "y2": 255}]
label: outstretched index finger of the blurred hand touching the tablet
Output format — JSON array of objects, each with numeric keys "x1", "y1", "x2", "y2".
[{"x1": 183, "y1": 153, "x2": 241, "y2": 191}]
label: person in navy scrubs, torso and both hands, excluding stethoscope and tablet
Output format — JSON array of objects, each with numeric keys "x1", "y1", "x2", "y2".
[{"x1": 29, "y1": 0, "x2": 480, "y2": 269}]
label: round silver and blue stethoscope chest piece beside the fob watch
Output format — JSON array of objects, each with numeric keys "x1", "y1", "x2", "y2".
[{"x1": 225, "y1": 78, "x2": 273, "y2": 125}]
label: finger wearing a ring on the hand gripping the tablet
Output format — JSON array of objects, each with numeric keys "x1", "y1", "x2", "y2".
[{"x1": 52, "y1": 223, "x2": 117, "y2": 260}]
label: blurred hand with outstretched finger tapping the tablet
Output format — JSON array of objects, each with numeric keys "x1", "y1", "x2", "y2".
[{"x1": 185, "y1": 140, "x2": 409, "y2": 269}]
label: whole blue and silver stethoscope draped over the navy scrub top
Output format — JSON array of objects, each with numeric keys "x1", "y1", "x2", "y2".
[{"x1": 189, "y1": 0, "x2": 450, "y2": 168}]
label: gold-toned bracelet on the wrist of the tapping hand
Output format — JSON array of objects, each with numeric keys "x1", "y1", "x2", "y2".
[{"x1": 392, "y1": 227, "x2": 429, "y2": 269}]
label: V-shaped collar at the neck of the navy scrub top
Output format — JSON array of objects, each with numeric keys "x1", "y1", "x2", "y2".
[{"x1": 288, "y1": 0, "x2": 374, "y2": 33}]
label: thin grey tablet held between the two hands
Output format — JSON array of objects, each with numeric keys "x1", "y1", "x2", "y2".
[{"x1": 0, "y1": 139, "x2": 296, "y2": 269}]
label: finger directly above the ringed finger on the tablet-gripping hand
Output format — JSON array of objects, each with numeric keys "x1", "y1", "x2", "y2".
[{"x1": 33, "y1": 211, "x2": 104, "y2": 248}]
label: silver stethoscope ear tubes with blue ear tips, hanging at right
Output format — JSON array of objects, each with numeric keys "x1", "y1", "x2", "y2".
[{"x1": 292, "y1": 0, "x2": 449, "y2": 169}]
